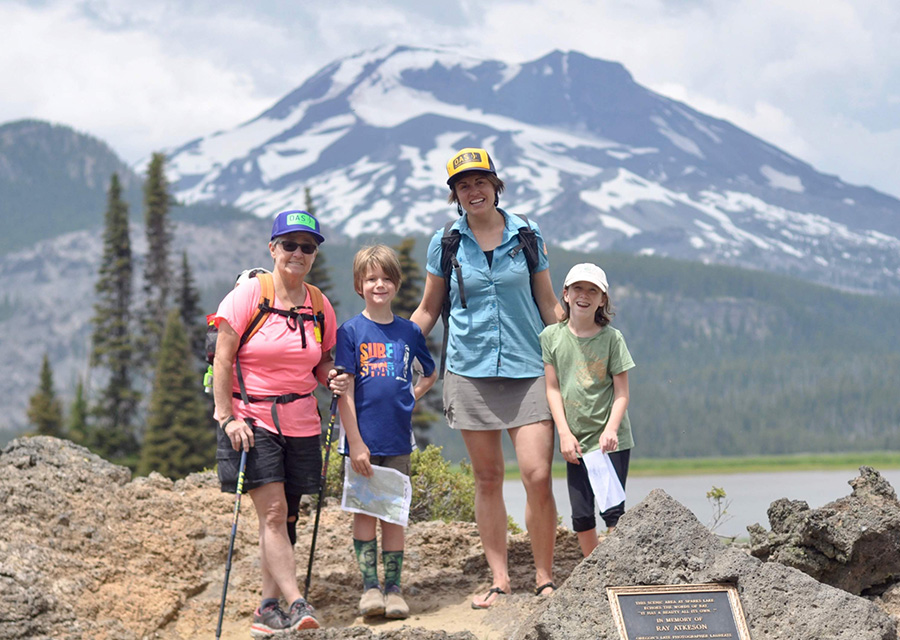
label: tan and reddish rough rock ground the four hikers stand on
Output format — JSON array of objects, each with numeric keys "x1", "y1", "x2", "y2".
[{"x1": 0, "y1": 437, "x2": 581, "y2": 640}]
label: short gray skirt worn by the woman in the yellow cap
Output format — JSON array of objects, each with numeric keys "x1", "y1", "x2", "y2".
[{"x1": 444, "y1": 371, "x2": 552, "y2": 431}]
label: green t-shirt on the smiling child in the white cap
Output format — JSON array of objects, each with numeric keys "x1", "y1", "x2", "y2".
[{"x1": 541, "y1": 322, "x2": 634, "y2": 453}]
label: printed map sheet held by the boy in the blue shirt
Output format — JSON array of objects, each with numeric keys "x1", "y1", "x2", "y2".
[{"x1": 341, "y1": 459, "x2": 412, "y2": 527}]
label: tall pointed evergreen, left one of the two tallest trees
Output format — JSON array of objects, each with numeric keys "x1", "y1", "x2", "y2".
[{"x1": 88, "y1": 173, "x2": 138, "y2": 464}]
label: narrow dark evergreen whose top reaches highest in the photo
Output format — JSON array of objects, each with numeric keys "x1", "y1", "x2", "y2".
[{"x1": 140, "y1": 153, "x2": 172, "y2": 366}]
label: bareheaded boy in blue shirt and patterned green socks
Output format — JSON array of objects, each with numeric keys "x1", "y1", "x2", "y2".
[{"x1": 335, "y1": 245, "x2": 437, "y2": 619}]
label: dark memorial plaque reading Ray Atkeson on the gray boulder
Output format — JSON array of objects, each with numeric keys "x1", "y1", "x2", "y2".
[{"x1": 606, "y1": 584, "x2": 750, "y2": 640}]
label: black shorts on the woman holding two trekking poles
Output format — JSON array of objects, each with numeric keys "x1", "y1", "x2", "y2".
[{"x1": 216, "y1": 427, "x2": 322, "y2": 496}]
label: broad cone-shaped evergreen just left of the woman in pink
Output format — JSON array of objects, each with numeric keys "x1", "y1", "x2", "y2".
[{"x1": 138, "y1": 309, "x2": 216, "y2": 479}]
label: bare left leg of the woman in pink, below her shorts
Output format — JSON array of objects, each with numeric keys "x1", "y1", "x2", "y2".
[{"x1": 249, "y1": 482, "x2": 301, "y2": 603}]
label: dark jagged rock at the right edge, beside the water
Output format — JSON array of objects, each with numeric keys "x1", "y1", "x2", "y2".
[{"x1": 748, "y1": 467, "x2": 900, "y2": 594}]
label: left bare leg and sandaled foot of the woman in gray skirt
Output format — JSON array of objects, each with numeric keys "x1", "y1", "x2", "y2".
[{"x1": 460, "y1": 429, "x2": 510, "y2": 606}]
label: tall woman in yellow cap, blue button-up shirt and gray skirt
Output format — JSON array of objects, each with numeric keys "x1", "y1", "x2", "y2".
[{"x1": 411, "y1": 148, "x2": 561, "y2": 609}]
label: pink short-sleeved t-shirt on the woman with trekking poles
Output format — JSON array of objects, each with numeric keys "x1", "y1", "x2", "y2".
[{"x1": 216, "y1": 278, "x2": 337, "y2": 437}]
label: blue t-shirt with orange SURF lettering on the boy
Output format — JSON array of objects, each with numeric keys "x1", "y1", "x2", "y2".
[{"x1": 334, "y1": 314, "x2": 434, "y2": 456}]
